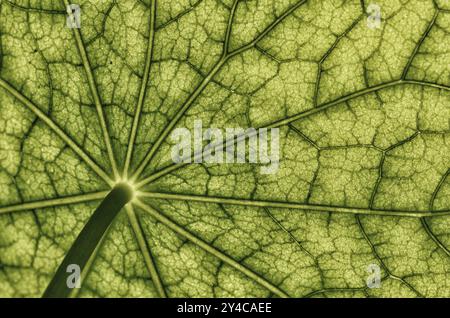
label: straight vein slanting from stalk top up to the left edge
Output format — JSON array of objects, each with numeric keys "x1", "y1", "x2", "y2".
[{"x1": 0, "y1": 78, "x2": 113, "y2": 185}]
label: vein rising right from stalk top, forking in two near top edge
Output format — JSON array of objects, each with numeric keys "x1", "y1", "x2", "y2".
[{"x1": 131, "y1": 0, "x2": 306, "y2": 180}]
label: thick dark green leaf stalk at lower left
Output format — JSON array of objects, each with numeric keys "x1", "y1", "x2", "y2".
[{"x1": 43, "y1": 183, "x2": 133, "y2": 298}]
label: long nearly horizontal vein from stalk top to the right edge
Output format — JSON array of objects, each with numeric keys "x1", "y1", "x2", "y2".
[{"x1": 139, "y1": 192, "x2": 450, "y2": 218}]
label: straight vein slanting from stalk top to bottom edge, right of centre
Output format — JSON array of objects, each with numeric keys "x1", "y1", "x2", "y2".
[{"x1": 135, "y1": 201, "x2": 289, "y2": 298}]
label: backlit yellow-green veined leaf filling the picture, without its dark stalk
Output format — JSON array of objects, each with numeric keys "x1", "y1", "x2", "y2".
[{"x1": 0, "y1": 0, "x2": 450, "y2": 297}]
